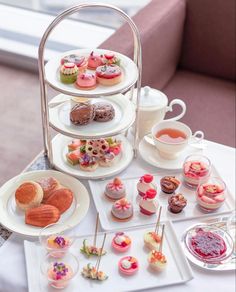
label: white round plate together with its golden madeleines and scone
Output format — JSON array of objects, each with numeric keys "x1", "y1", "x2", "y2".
[{"x1": 0, "y1": 170, "x2": 90, "y2": 236}]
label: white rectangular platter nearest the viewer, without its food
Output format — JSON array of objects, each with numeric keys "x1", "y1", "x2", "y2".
[{"x1": 24, "y1": 222, "x2": 193, "y2": 292}]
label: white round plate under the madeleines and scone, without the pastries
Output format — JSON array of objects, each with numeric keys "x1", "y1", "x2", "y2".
[{"x1": 0, "y1": 170, "x2": 90, "y2": 236}]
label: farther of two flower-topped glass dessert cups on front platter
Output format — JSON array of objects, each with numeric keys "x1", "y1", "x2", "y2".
[{"x1": 39, "y1": 223, "x2": 75, "y2": 252}]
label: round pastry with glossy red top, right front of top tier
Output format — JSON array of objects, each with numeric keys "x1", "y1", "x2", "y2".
[{"x1": 96, "y1": 65, "x2": 122, "y2": 86}]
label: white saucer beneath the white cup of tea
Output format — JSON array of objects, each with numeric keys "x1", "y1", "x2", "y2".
[{"x1": 139, "y1": 138, "x2": 202, "y2": 170}]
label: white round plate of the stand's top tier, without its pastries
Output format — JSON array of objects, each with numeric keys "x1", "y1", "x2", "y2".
[{"x1": 45, "y1": 49, "x2": 138, "y2": 97}]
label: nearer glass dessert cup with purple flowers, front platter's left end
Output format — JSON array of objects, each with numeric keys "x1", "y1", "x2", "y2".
[{"x1": 40, "y1": 251, "x2": 79, "y2": 289}]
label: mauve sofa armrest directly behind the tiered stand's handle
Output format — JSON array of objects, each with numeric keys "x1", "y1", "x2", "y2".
[{"x1": 101, "y1": 0, "x2": 185, "y2": 87}]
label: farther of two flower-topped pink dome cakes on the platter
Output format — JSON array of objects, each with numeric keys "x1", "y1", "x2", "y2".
[{"x1": 104, "y1": 177, "x2": 126, "y2": 200}]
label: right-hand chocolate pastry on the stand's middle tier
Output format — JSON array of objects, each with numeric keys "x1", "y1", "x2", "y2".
[{"x1": 94, "y1": 102, "x2": 115, "y2": 122}]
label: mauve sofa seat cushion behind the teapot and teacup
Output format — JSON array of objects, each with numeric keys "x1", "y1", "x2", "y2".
[{"x1": 159, "y1": 71, "x2": 235, "y2": 147}]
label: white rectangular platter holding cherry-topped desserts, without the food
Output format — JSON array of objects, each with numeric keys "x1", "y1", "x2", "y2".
[{"x1": 89, "y1": 167, "x2": 235, "y2": 230}]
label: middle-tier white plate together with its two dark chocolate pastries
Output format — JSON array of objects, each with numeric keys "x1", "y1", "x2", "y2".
[{"x1": 49, "y1": 94, "x2": 135, "y2": 139}]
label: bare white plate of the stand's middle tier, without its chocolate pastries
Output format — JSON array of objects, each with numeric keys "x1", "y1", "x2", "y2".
[{"x1": 49, "y1": 94, "x2": 135, "y2": 139}]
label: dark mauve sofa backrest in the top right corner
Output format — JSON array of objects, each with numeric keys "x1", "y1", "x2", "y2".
[{"x1": 180, "y1": 0, "x2": 236, "y2": 80}]
